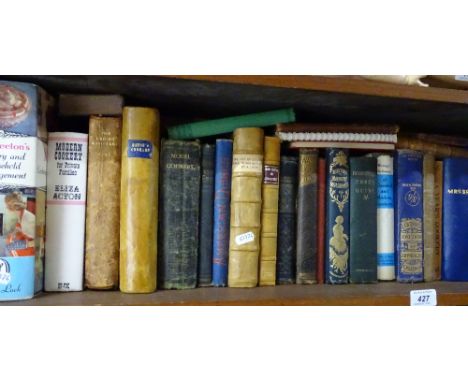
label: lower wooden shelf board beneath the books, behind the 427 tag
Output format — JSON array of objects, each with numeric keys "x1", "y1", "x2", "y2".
[{"x1": 0, "y1": 282, "x2": 468, "y2": 306}]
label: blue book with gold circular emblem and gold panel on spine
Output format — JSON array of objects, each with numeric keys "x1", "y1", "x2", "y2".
[{"x1": 394, "y1": 150, "x2": 424, "y2": 282}]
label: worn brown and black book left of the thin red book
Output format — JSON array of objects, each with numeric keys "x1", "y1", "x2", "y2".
[{"x1": 296, "y1": 149, "x2": 318, "y2": 284}]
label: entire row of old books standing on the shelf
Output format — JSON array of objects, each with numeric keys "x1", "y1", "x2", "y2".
[{"x1": 0, "y1": 81, "x2": 468, "y2": 299}]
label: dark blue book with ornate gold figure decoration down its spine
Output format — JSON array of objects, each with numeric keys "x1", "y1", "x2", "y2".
[{"x1": 325, "y1": 148, "x2": 349, "y2": 284}]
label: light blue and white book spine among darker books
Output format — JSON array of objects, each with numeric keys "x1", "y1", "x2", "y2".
[{"x1": 377, "y1": 155, "x2": 395, "y2": 281}]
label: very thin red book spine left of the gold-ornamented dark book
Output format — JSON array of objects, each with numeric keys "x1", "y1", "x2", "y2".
[{"x1": 317, "y1": 158, "x2": 327, "y2": 284}]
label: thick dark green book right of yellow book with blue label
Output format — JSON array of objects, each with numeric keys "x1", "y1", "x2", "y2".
[{"x1": 158, "y1": 140, "x2": 201, "y2": 289}]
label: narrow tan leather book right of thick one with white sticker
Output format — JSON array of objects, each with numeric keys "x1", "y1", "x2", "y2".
[{"x1": 259, "y1": 137, "x2": 281, "y2": 286}]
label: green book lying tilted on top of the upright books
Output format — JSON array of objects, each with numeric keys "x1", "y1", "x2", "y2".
[{"x1": 168, "y1": 108, "x2": 296, "y2": 139}]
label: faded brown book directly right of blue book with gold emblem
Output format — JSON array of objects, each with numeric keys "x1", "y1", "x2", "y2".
[{"x1": 423, "y1": 153, "x2": 438, "y2": 282}]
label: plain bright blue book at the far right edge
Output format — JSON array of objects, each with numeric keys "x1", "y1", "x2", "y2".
[{"x1": 442, "y1": 158, "x2": 468, "y2": 281}]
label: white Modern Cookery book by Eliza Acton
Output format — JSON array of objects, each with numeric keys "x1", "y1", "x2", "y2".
[{"x1": 45, "y1": 132, "x2": 88, "y2": 292}]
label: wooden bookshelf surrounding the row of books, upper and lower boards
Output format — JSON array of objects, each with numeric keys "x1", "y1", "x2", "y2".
[{"x1": 0, "y1": 76, "x2": 468, "y2": 306}]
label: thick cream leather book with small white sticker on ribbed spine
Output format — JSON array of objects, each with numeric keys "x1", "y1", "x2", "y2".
[{"x1": 228, "y1": 127, "x2": 263, "y2": 287}]
